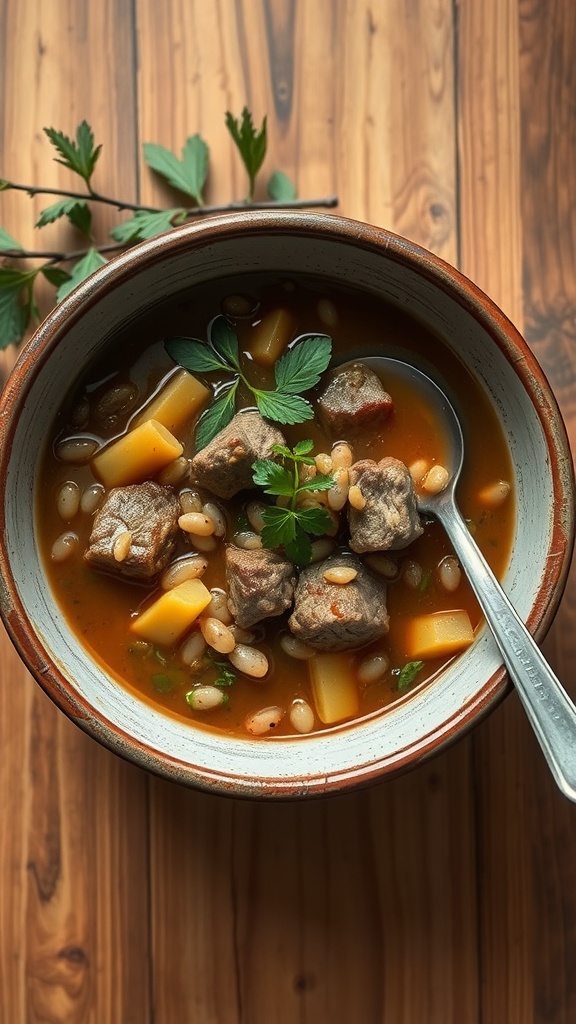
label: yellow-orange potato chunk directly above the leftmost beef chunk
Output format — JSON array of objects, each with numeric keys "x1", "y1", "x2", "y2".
[{"x1": 92, "y1": 420, "x2": 183, "y2": 487}]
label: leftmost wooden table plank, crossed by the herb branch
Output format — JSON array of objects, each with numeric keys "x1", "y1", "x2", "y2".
[{"x1": 0, "y1": 0, "x2": 150, "y2": 1024}]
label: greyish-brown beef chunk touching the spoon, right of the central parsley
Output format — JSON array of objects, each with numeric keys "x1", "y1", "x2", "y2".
[{"x1": 348, "y1": 458, "x2": 422, "y2": 552}]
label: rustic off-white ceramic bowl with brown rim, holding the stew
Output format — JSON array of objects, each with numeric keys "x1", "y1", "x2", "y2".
[{"x1": 0, "y1": 211, "x2": 574, "y2": 798}]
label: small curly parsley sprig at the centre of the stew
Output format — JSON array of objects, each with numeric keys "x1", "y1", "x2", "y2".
[{"x1": 252, "y1": 440, "x2": 334, "y2": 565}]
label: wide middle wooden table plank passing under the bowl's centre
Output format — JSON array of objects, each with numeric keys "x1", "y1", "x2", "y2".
[{"x1": 136, "y1": 0, "x2": 478, "y2": 1024}]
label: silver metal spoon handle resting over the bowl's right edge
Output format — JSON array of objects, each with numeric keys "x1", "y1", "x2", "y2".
[{"x1": 435, "y1": 503, "x2": 576, "y2": 802}]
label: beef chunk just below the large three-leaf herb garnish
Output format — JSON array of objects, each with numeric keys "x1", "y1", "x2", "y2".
[{"x1": 192, "y1": 412, "x2": 286, "y2": 498}]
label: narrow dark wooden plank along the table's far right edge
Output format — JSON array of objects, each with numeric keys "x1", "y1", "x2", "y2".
[{"x1": 519, "y1": 0, "x2": 576, "y2": 1024}]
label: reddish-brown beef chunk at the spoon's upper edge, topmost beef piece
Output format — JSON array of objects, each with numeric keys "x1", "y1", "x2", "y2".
[{"x1": 318, "y1": 362, "x2": 393, "y2": 437}]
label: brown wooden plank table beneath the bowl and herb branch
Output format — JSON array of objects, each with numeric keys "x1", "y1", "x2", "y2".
[{"x1": 0, "y1": 0, "x2": 576, "y2": 1024}]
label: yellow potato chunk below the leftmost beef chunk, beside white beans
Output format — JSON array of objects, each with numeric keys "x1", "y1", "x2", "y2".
[{"x1": 130, "y1": 580, "x2": 212, "y2": 646}]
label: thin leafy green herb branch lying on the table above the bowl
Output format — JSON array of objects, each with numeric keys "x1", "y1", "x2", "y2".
[{"x1": 0, "y1": 106, "x2": 337, "y2": 348}]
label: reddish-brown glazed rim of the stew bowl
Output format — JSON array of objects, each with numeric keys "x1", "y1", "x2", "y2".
[{"x1": 0, "y1": 210, "x2": 575, "y2": 798}]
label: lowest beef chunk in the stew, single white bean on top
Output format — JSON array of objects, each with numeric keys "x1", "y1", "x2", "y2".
[{"x1": 288, "y1": 552, "x2": 388, "y2": 650}]
